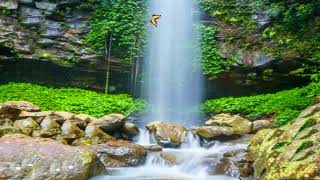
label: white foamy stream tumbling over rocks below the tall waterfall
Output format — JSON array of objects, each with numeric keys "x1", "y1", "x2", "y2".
[{"x1": 93, "y1": 132, "x2": 247, "y2": 180}]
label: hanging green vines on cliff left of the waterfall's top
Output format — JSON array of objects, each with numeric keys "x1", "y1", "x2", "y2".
[{"x1": 86, "y1": 0, "x2": 146, "y2": 62}]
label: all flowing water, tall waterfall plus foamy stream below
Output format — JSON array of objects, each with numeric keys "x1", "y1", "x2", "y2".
[{"x1": 94, "y1": 0, "x2": 246, "y2": 180}]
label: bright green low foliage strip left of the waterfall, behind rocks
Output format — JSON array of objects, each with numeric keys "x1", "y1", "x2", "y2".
[{"x1": 0, "y1": 83, "x2": 144, "y2": 117}]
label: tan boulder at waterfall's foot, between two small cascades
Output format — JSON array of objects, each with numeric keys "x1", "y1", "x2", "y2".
[{"x1": 146, "y1": 121, "x2": 188, "y2": 147}]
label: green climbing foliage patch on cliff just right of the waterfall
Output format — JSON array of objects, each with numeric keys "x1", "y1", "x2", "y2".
[{"x1": 198, "y1": 25, "x2": 236, "y2": 79}]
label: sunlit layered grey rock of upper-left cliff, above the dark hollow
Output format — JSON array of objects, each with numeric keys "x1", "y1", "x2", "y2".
[{"x1": 0, "y1": 0, "x2": 101, "y2": 65}]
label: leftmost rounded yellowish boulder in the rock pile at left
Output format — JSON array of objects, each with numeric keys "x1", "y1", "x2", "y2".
[{"x1": 13, "y1": 118, "x2": 40, "y2": 135}]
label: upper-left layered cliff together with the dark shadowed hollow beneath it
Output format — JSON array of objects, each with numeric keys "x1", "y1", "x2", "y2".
[{"x1": 0, "y1": 0, "x2": 130, "y2": 92}]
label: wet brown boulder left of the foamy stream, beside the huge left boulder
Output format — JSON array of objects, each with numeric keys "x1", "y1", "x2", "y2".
[{"x1": 85, "y1": 140, "x2": 147, "y2": 168}]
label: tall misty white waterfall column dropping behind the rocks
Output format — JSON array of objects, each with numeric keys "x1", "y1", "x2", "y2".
[{"x1": 145, "y1": 0, "x2": 202, "y2": 126}]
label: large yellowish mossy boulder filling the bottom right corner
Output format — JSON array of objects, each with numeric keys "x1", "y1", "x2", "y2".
[{"x1": 248, "y1": 103, "x2": 320, "y2": 180}]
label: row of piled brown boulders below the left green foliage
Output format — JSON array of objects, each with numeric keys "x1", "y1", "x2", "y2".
[{"x1": 0, "y1": 101, "x2": 139, "y2": 145}]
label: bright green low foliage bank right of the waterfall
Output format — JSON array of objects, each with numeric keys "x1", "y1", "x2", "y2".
[{"x1": 202, "y1": 83, "x2": 320, "y2": 126}]
